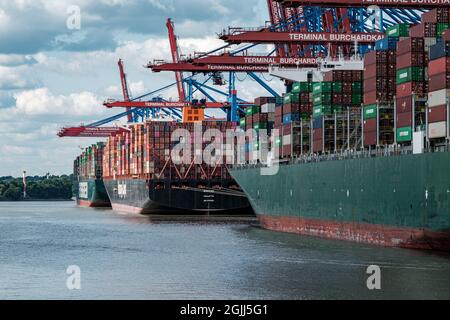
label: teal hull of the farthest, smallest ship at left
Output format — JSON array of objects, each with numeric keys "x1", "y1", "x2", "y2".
[{"x1": 74, "y1": 179, "x2": 111, "y2": 208}]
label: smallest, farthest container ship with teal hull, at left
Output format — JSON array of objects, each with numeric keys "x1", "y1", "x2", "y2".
[{"x1": 73, "y1": 142, "x2": 111, "y2": 207}]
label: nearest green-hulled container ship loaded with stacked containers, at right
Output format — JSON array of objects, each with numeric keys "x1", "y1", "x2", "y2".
[{"x1": 230, "y1": 12, "x2": 450, "y2": 250}]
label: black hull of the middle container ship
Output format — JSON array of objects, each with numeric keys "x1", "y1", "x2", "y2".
[{"x1": 105, "y1": 179, "x2": 252, "y2": 215}]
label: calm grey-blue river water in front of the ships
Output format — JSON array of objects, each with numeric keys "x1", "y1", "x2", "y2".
[{"x1": 0, "y1": 202, "x2": 450, "y2": 299}]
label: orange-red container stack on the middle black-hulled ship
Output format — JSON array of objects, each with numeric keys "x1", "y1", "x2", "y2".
[{"x1": 103, "y1": 121, "x2": 236, "y2": 181}]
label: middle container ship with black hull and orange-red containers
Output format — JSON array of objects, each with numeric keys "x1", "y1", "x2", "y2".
[{"x1": 103, "y1": 121, "x2": 252, "y2": 215}]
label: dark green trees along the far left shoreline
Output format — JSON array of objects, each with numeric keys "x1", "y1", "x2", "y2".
[{"x1": 0, "y1": 175, "x2": 73, "y2": 201}]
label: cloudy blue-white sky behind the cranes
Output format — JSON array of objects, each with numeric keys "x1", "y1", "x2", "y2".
[{"x1": 0, "y1": 0, "x2": 282, "y2": 176}]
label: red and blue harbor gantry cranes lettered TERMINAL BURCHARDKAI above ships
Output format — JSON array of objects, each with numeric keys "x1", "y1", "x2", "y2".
[{"x1": 59, "y1": 0, "x2": 440, "y2": 136}]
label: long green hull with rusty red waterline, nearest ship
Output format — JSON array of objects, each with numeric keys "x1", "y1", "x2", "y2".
[{"x1": 230, "y1": 152, "x2": 450, "y2": 251}]
